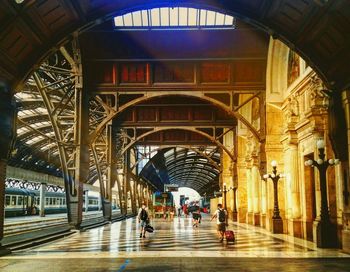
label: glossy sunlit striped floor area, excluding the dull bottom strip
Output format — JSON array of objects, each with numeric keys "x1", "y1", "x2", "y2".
[{"x1": 4, "y1": 216, "x2": 350, "y2": 257}]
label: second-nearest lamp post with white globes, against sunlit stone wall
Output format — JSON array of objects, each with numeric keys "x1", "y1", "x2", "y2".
[{"x1": 263, "y1": 161, "x2": 283, "y2": 233}]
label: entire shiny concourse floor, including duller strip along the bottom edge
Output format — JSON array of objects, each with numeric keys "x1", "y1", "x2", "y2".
[{"x1": 0, "y1": 217, "x2": 350, "y2": 271}]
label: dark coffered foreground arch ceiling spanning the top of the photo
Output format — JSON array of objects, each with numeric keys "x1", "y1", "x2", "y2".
[{"x1": 0, "y1": 0, "x2": 350, "y2": 89}]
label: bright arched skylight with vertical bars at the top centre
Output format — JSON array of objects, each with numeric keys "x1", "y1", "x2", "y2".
[{"x1": 114, "y1": 7, "x2": 235, "y2": 29}]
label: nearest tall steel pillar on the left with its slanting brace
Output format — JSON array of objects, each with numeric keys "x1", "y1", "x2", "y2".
[{"x1": 58, "y1": 41, "x2": 90, "y2": 229}]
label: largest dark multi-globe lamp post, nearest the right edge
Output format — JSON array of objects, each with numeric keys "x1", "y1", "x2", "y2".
[{"x1": 305, "y1": 139, "x2": 339, "y2": 248}]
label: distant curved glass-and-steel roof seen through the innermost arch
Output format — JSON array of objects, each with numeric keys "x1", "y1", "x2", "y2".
[{"x1": 140, "y1": 146, "x2": 220, "y2": 195}]
